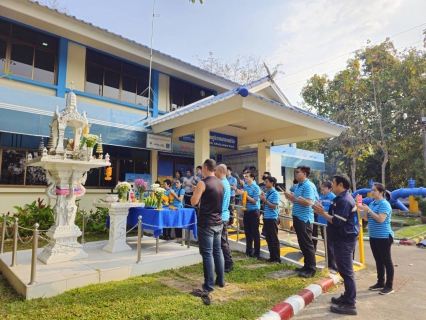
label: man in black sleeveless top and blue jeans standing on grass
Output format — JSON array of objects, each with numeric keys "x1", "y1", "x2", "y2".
[{"x1": 191, "y1": 159, "x2": 225, "y2": 304}]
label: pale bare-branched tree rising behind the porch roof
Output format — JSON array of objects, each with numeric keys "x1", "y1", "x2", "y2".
[{"x1": 195, "y1": 52, "x2": 283, "y2": 84}]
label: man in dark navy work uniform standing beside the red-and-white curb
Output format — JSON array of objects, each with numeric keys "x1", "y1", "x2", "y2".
[{"x1": 313, "y1": 175, "x2": 359, "y2": 315}]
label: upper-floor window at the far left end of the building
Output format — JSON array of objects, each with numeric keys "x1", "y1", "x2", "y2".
[{"x1": 0, "y1": 19, "x2": 58, "y2": 84}]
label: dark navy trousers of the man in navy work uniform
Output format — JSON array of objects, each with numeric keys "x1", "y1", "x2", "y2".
[{"x1": 333, "y1": 240, "x2": 356, "y2": 306}]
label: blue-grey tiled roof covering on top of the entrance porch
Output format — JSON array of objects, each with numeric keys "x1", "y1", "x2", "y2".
[{"x1": 146, "y1": 76, "x2": 348, "y2": 129}]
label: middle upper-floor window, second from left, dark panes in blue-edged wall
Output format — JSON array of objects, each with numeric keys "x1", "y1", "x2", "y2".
[{"x1": 86, "y1": 49, "x2": 149, "y2": 106}]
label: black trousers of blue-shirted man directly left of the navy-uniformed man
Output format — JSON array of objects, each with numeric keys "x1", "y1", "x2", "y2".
[{"x1": 293, "y1": 217, "x2": 317, "y2": 272}]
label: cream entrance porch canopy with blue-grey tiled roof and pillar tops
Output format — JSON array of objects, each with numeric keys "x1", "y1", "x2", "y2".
[{"x1": 146, "y1": 77, "x2": 347, "y2": 172}]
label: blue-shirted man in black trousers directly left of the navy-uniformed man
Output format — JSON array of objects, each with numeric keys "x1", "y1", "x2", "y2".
[{"x1": 285, "y1": 166, "x2": 317, "y2": 278}]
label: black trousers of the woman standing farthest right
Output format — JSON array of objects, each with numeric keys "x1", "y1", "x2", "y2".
[{"x1": 370, "y1": 235, "x2": 394, "y2": 289}]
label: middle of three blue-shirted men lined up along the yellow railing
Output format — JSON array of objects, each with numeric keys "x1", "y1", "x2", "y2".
[{"x1": 259, "y1": 177, "x2": 281, "y2": 263}]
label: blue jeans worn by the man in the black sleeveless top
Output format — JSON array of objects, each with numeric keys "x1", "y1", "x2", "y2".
[{"x1": 198, "y1": 225, "x2": 225, "y2": 292}]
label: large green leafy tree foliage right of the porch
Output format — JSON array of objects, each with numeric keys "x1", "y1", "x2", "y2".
[{"x1": 298, "y1": 39, "x2": 426, "y2": 189}]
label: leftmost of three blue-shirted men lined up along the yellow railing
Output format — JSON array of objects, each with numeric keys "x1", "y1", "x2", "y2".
[{"x1": 236, "y1": 172, "x2": 260, "y2": 259}]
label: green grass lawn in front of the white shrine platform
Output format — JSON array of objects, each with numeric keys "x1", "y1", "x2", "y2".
[{"x1": 0, "y1": 234, "x2": 324, "y2": 320}]
